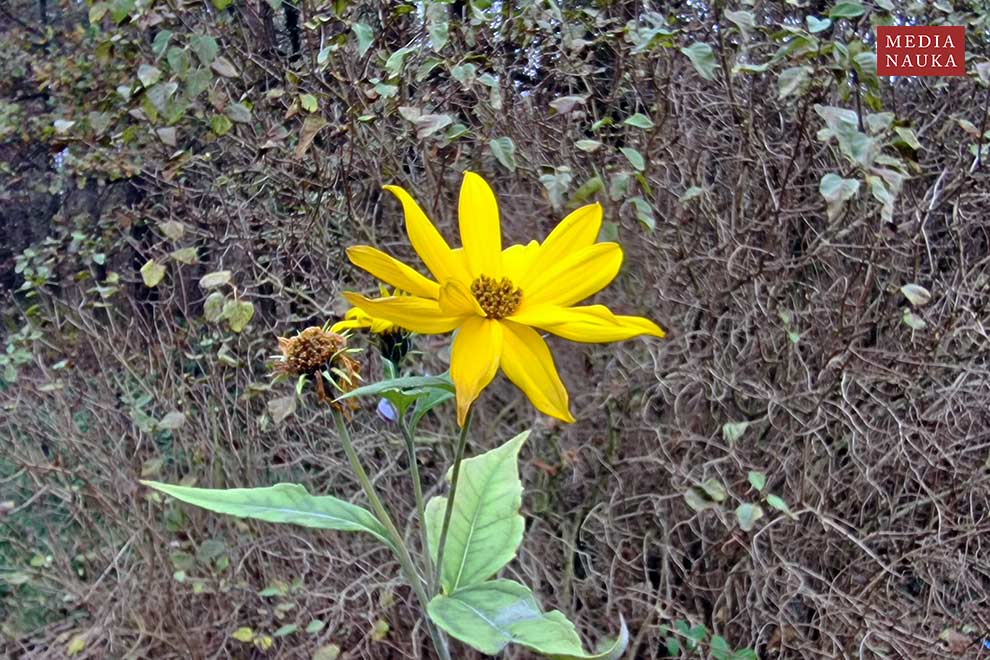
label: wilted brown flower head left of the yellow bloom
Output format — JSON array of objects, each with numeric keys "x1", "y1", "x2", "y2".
[{"x1": 275, "y1": 326, "x2": 361, "y2": 408}]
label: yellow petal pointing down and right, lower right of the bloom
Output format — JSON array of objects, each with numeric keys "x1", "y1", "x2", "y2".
[{"x1": 502, "y1": 321, "x2": 574, "y2": 422}]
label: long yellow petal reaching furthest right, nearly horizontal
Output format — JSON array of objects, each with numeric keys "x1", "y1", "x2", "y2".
[{"x1": 509, "y1": 305, "x2": 666, "y2": 344}]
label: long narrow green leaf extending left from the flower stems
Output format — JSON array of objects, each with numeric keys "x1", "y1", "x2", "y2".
[{"x1": 141, "y1": 481, "x2": 393, "y2": 547}]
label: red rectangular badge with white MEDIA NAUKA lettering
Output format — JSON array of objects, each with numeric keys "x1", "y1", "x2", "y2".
[{"x1": 877, "y1": 25, "x2": 966, "y2": 76}]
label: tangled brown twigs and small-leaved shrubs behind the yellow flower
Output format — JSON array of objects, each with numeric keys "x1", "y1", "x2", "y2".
[{"x1": 0, "y1": 0, "x2": 990, "y2": 658}]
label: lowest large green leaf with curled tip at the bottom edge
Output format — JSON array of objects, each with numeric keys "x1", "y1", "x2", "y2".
[{"x1": 427, "y1": 580, "x2": 629, "y2": 660}]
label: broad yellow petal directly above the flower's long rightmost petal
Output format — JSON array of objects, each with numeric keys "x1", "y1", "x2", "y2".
[{"x1": 519, "y1": 243, "x2": 622, "y2": 312}]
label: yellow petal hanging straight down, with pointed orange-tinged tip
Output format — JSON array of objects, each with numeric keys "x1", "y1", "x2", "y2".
[{"x1": 450, "y1": 316, "x2": 502, "y2": 426}]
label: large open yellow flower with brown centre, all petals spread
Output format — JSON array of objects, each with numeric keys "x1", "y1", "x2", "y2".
[{"x1": 344, "y1": 172, "x2": 664, "y2": 426}]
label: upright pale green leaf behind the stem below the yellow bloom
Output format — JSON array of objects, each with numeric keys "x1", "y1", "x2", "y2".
[{"x1": 426, "y1": 431, "x2": 529, "y2": 594}]
